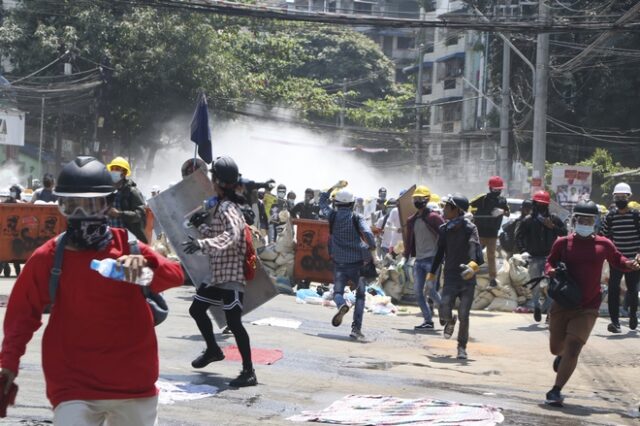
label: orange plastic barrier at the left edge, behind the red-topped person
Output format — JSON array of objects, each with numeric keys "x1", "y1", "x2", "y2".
[{"x1": 0, "y1": 203, "x2": 67, "y2": 262}]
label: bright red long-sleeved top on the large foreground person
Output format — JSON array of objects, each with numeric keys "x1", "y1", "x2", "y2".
[{"x1": 0, "y1": 229, "x2": 184, "y2": 407}]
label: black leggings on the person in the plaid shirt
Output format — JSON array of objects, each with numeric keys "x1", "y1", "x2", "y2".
[{"x1": 189, "y1": 299, "x2": 253, "y2": 370}]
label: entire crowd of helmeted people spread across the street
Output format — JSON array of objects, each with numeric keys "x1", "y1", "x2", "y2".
[{"x1": 0, "y1": 151, "x2": 640, "y2": 425}]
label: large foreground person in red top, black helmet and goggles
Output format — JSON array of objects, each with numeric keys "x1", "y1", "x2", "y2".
[{"x1": 0, "y1": 157, "x2": 184, "y2": 426}]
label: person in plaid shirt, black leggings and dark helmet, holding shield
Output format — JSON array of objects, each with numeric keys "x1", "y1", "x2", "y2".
[{"x1": 182, "y1": 156, "x2": 258, "y2": 387}]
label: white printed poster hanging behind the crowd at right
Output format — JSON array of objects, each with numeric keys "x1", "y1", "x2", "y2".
[{"x1": 551, "y1": 165, "x2": 593, "y2": 210}]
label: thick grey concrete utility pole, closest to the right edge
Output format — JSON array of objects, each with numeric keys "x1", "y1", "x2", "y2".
[{"x1": 531, "y1": 0, "x2": 549, "y2": 190}]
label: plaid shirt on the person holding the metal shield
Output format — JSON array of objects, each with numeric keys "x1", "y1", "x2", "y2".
[{"x1": 198, "y1": 200, "x2": 247, "y2": 285}]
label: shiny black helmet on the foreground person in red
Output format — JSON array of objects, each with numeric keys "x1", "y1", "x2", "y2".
[{"x1": 53, "y1": 156, "x2": 115, "y2": 197}]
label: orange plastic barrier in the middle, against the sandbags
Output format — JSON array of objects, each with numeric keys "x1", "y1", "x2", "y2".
[{"x1": 293, "y1": 219, "x2": 333, "y2": 283}]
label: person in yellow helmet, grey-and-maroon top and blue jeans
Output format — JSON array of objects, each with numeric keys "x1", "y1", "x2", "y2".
[{"x1": 404, "y1": 185, "x2": 444, "y2": 330}]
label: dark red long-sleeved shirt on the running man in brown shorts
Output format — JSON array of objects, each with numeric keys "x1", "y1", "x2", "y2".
[{"x1": 545, "y1": 235, "x2": 629, "y2": 309}]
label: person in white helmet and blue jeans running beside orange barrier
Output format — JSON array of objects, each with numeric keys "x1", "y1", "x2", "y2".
[{"x1": 320, "y1": 182, "x2": 376, "y2": 340}]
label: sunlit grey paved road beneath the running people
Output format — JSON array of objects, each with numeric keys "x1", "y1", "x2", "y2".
[{"x1": 0, "y1": 278, "x2": 640, "y2": 426}]
